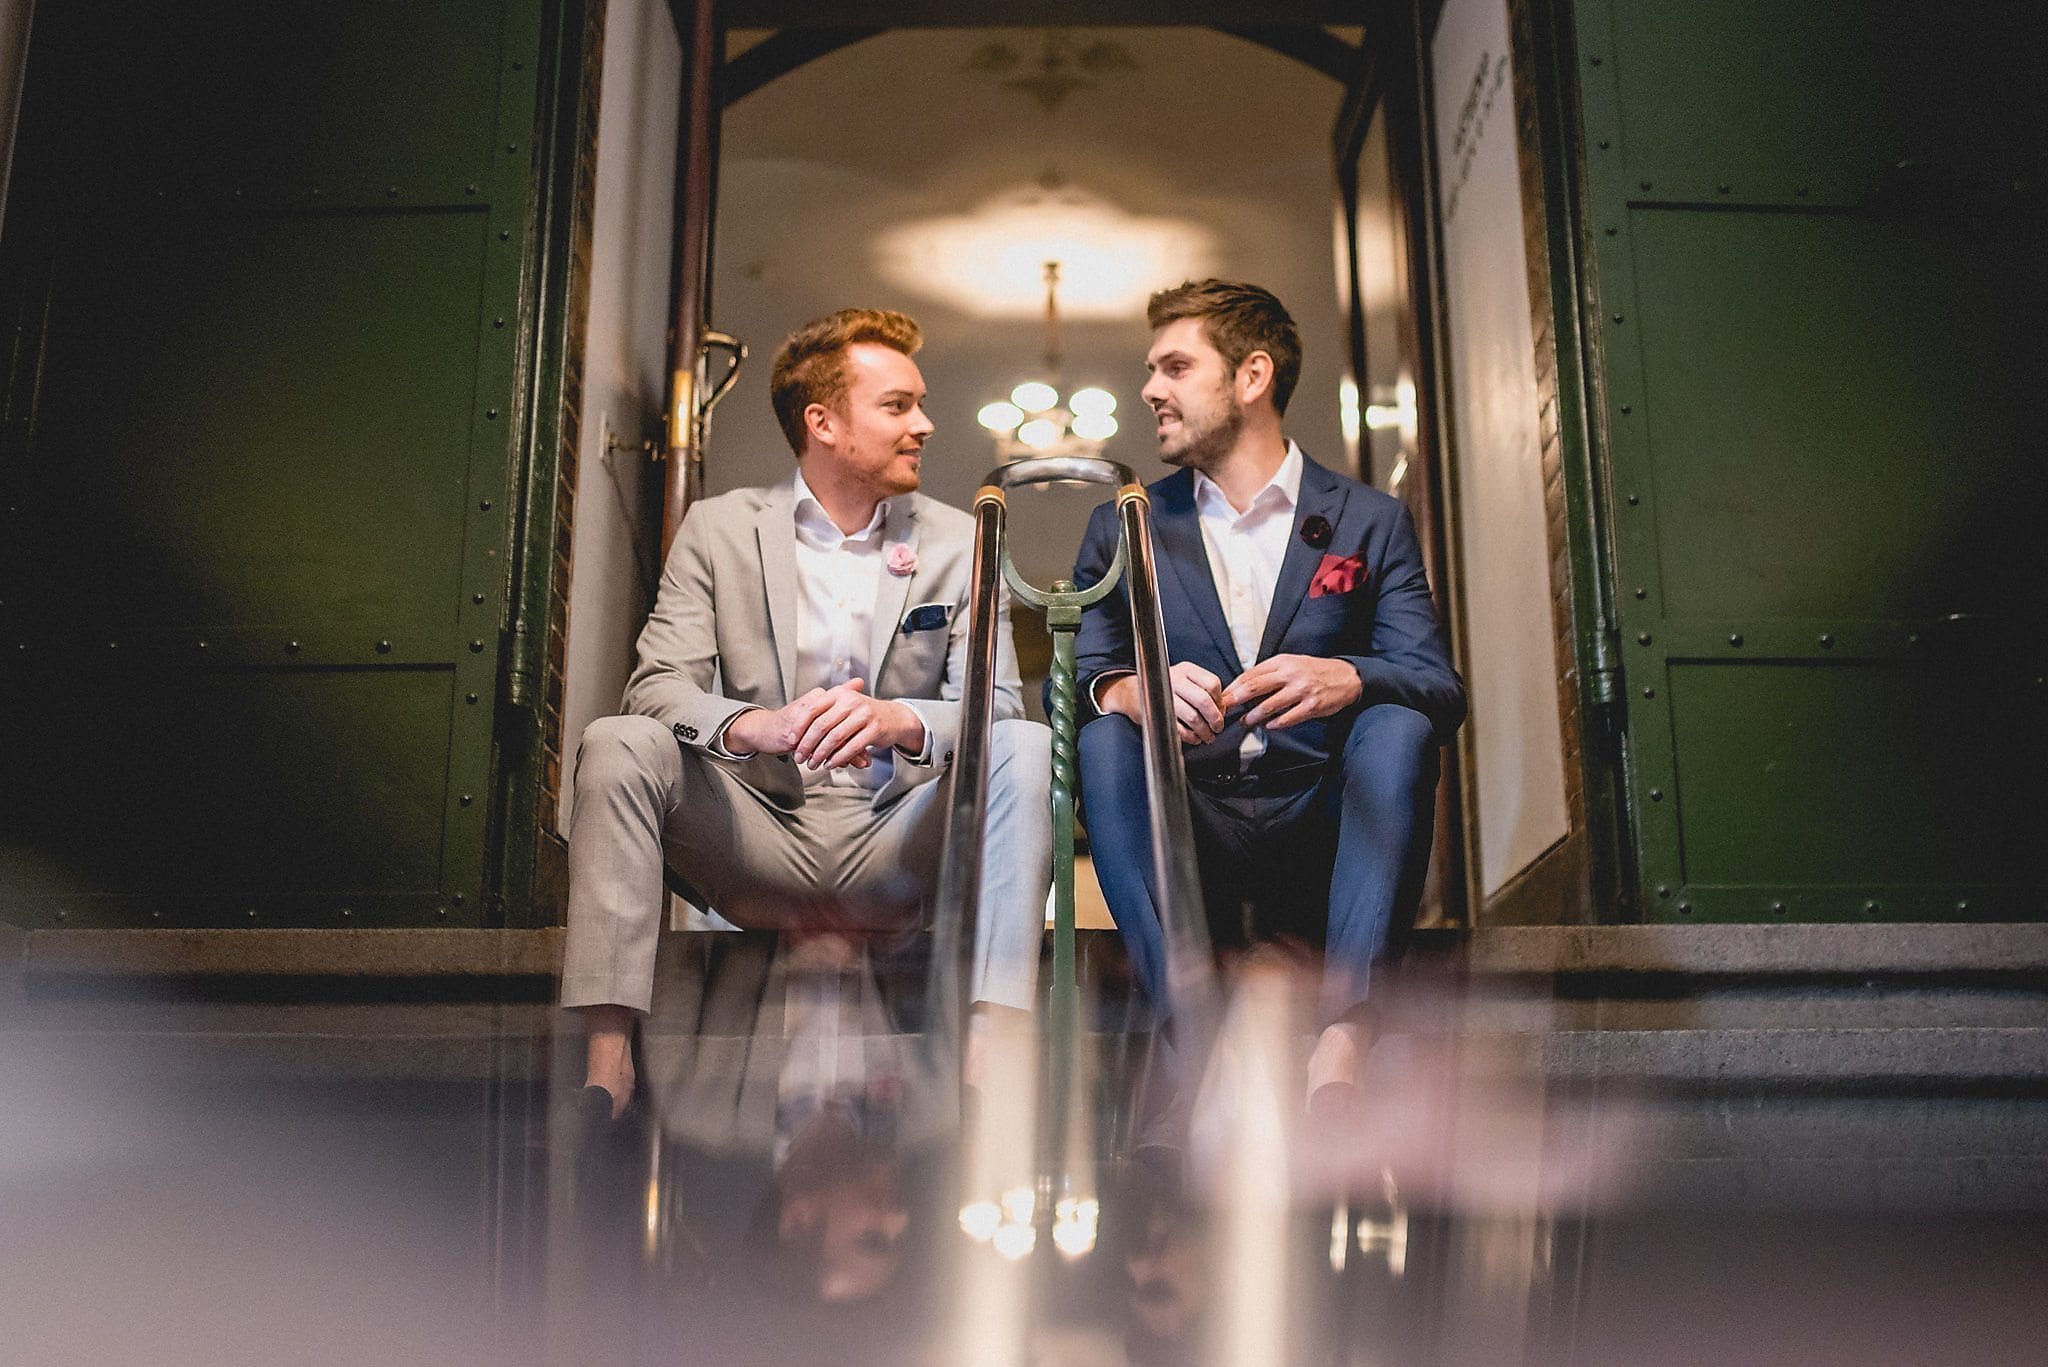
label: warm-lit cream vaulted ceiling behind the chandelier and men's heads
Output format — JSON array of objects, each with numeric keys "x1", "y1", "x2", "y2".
[{"x1": 707, "y1": 24, "x2": 1343, "y2": 580}]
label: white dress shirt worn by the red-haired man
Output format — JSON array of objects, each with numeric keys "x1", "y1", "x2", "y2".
[{"x1": 791, "y1": 473, "x2": 932, "y2": 789}]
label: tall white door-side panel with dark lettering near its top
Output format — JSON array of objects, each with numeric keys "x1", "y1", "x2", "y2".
[{"x1": 1432, "y1": 0, "x2": 1569, "y2": 896}]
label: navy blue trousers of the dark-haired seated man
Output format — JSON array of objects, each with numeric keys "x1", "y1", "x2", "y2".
[{"x1": 1081, "y1": 703, "x2": 1440, "y2": 1023}]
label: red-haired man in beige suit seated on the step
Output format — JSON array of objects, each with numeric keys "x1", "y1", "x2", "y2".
[{"x1": 561, "y1": 309, "x2": 1053, "y2": 1117}]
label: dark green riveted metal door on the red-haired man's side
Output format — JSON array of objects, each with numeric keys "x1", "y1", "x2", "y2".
[{"x1": 0, "y1": 0, "x2": 561, "y2": 926}]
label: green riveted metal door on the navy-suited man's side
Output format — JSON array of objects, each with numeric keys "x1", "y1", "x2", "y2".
[{"x1": 1575, "y1": 0, "x2": 2048, "y2": 920}]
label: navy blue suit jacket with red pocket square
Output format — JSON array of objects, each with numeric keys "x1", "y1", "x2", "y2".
[{"x1": 1073, "y1": 448, "x2": 1464, "y2": 773}]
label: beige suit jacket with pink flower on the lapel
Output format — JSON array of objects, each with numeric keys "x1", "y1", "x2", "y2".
[{"x1": 621, "y1": 478, "x2": 1024, "y2": 810}]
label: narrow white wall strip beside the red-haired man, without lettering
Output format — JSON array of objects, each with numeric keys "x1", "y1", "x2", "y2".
[{"x1": 557, "y1": 0, "x2": 682, "y2": 832}]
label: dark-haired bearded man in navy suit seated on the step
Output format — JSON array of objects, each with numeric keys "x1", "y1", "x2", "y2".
[{"x1": 1075, "y1": 281, "x2": 1464, "y2": 1109}]
